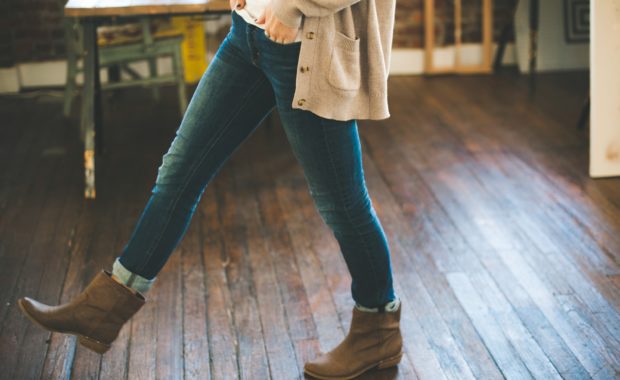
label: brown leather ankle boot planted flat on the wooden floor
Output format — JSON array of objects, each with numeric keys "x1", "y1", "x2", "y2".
[{"x1": 304, "y1": 301, "x2": 403, "y2": 380}]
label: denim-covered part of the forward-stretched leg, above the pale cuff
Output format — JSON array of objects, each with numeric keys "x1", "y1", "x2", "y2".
[{"x1": 115, "y1": 19, "x2": 275, "y2": 280}]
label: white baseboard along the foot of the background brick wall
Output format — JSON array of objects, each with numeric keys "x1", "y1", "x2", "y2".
[{"x1": 0, "y1": 44, "x2": 516, "y2": 94}]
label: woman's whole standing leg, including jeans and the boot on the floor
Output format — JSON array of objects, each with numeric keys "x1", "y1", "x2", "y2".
[{"x1": 256, "y1": 18, "x2": 402, "y2": 379}]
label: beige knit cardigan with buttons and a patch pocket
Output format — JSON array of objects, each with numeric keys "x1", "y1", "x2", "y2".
[{"x1": 272, "y1": 0, "x2": 396, "y2": 120}]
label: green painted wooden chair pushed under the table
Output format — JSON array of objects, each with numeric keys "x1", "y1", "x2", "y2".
[{"x1": 63, "y1": 17, "x2": 187, "y2": 120}]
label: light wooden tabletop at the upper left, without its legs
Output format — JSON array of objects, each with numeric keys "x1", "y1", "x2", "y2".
[{"x1": 64, "y1": 0, "x2": 231, "y2": 17}]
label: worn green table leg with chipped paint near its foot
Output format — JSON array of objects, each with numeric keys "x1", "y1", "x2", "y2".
[{"x1": 81, "y1": 19, "x2": 101, "y2": 198}]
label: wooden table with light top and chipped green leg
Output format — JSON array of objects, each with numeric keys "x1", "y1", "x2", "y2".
[{"x1": 64, "y1": 0, "x2": 231, "y2": 198}]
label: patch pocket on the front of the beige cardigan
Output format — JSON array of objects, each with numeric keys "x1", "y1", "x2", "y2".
[{"x1": 327, "y1": 30, "x2": 362, "y2": 91}]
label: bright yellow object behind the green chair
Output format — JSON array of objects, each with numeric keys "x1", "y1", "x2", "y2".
[{"x1": 172, "y1": 16, "x2": 207, "y2": 83}]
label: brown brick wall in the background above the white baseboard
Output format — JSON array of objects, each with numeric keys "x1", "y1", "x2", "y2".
[{"x1": 0, "y1": 0, "x2": 516, "y2": 67}]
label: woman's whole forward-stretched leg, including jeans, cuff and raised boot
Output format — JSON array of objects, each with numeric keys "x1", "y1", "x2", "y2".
[{"x1": 18, "y1": 11, "x2": 282, "y2": 353}]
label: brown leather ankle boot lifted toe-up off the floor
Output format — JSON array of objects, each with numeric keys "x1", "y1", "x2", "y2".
[{"x1": 18, "y1": 270, "x2": 146, "y2": 354}]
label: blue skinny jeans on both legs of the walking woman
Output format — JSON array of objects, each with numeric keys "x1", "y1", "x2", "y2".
[{"x1": 118, "y1": 11, "x2": 396, "y2": 307}]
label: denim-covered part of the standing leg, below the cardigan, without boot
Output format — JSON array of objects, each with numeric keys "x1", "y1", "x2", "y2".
[{"x1": 256, "y1": 25, "x2": 396, "y2": 308}]
